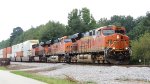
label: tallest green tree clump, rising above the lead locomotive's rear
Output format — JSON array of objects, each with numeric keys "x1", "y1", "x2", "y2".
[{"x1": 66, "y1": 8, "x2": 96, "y2": 35}]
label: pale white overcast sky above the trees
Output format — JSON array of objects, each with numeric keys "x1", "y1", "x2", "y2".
[{"x1": 0, "y1": 0, "x2": 150, "y2": 41}]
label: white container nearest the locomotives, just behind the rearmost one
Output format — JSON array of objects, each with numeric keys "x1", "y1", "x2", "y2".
[{"x1": 23, "y1": 40, "x2": 39, "y2": 57}]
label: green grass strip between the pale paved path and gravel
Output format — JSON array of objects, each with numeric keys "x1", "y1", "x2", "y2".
[{"x1": 11, "y1": 71, "x2": 77, "y2": 84}]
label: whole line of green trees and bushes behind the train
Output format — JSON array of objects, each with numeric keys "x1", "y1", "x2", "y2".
[{"x1": 0, "y1": 8, "x2": 150, "y2": 62}]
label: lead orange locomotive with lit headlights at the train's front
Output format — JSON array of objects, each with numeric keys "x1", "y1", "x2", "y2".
[{"x1": 66, "y1": 25, "x2": 131, "y2": 64}]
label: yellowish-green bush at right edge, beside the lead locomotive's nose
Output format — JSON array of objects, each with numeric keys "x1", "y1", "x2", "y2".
[{"x1": 131, "y1": 32, "x2": 150, "y2": 62}]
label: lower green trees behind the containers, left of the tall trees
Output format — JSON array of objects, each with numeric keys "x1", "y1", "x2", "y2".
[{"x1": 0, "y1": 21, "x2": 66, "y2": 48}]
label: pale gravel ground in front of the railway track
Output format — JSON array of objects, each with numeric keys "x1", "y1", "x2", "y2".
[{"x1": 7, "y1": 62, "x2": 150, "y2": 84}]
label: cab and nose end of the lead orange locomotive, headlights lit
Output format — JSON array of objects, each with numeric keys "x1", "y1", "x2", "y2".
[{"x1": 102, "y1": 26, "x2": 131, "y2": 64}]
